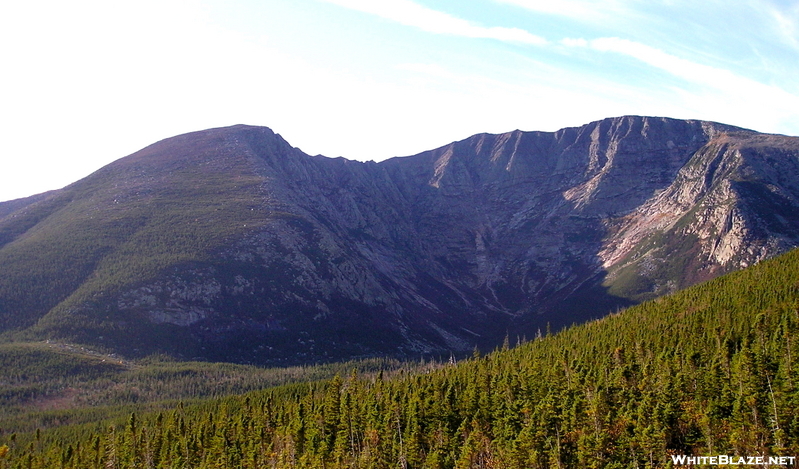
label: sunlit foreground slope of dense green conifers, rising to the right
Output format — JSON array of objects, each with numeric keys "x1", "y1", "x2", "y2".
[{"x1": 0, "y1": 250, "x2": 799, "y2": 469}]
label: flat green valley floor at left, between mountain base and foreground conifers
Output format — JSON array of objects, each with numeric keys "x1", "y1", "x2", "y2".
[{"x1": 0, "y1": 343, "x2": 410, "y2": 433}]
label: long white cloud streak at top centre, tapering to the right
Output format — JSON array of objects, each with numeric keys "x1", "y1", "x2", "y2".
[{"x1": 322, "y1": 0, "x2": 548, "y2": 45}]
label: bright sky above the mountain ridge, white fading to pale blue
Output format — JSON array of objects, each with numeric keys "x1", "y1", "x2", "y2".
[{"x1": 0, "y1": 0, "x2": 799, "y2": 201}]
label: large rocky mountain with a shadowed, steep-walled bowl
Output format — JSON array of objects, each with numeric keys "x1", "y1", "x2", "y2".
[{"x1": 0, "y1": 116, "x2": 799, "y2": 362}]
